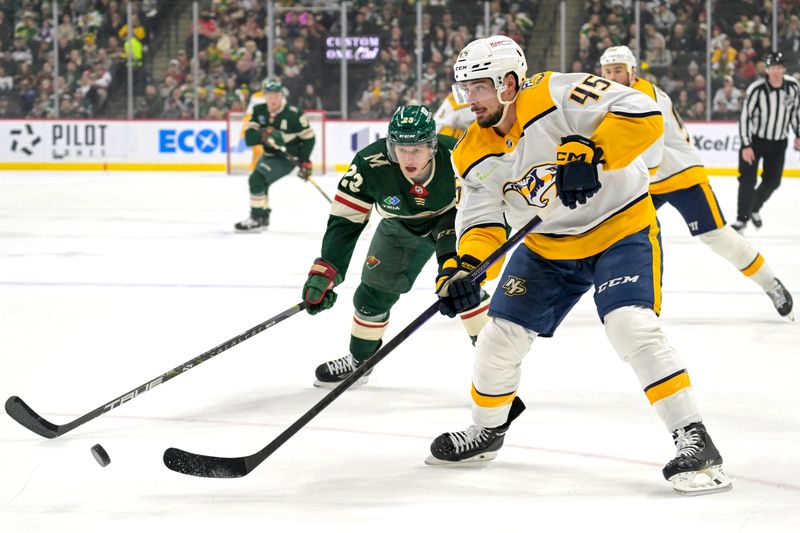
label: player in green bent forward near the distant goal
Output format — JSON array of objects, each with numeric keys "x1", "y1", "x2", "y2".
[{"x1": 234, "y1": 80, "x2": 315, "y2": 233}]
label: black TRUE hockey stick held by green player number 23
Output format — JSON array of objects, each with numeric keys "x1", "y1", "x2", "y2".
[{"x1": 6, "y1": 302, "x2": 307, "y2": 439}]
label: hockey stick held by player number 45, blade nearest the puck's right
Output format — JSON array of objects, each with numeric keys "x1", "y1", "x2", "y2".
[{"x1": 159, "y1": 205, "x2": 560, "y2": 478}]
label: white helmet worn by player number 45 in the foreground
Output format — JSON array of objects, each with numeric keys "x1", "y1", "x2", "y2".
[{"x1": 453, "y1": 35, "x2": 528, "y2": 104}]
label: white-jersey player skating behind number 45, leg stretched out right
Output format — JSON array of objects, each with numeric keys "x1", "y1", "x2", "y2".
[{"x1": 600, "y1": 46, "x2": 794, "y2": 320}]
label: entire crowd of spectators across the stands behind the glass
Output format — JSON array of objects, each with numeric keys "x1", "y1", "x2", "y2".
[{"x1": 0, "y1": 0, "x2": 800, "y2": 120}]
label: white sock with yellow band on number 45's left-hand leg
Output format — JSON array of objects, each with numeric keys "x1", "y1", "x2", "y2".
[{"x1": 472, "y1": 317, "x2": 536, "y2": 427}]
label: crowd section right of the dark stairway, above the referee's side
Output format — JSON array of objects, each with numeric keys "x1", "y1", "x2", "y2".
[{"x1": 571, "y1": 0, "x2": 800, "y2": 120}]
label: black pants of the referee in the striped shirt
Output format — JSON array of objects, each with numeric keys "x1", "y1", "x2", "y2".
[{"x1": 736, "y1": 137, "x2": 787, "y2": 220}]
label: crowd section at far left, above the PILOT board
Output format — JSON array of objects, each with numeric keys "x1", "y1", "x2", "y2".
[{"x1": 0, "y1": 0, "x2": 159, "y2": 118}]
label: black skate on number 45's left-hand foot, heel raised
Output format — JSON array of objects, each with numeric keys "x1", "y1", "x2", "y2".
[{"x1": 425, "y1": 397, "x2": 525, "y2": 465}]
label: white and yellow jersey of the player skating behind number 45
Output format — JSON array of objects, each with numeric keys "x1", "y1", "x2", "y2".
[{"x1": 633, "y1": 78, "x2": 708, "y2": 194}]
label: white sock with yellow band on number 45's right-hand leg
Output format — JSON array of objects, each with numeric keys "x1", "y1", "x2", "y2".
[{"x1": 605, "y1": 306, "x2": 701, "y2": 432}]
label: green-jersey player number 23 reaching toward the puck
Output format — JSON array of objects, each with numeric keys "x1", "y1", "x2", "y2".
[{"x1": 303, "y1": 106, "x2": 488, "y2": 387}]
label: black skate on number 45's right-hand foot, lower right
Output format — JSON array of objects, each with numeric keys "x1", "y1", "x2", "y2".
[{"x1": 662, "y1": 422, "x2": 733, "y2": 496}]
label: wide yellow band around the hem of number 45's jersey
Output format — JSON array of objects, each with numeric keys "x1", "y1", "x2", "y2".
[{"x1": 525, "y1": 194, "x2": 656, "y2": 260}]
